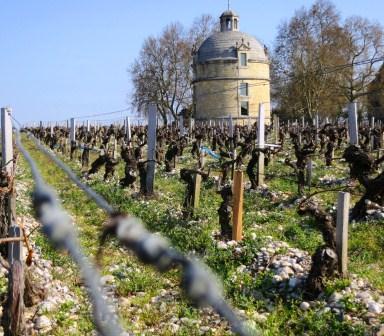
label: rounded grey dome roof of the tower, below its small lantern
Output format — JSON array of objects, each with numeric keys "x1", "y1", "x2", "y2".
[{"x1": 197, "y1": 31, "x2": 268, "y2": 63}]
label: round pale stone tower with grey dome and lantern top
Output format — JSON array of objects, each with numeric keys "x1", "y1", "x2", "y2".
[{"x1": 193, "y1": 10, "x2": 271, "y2": 122}]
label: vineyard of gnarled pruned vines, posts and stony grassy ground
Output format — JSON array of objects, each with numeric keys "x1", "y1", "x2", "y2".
[{"x1": 0, "y1": 107, "x2": 384, "y2": 335}]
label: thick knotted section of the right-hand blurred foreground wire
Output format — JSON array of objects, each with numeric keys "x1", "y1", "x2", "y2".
[{"x1": 98, "y1": 216, "x2": 249, "y2": 336}]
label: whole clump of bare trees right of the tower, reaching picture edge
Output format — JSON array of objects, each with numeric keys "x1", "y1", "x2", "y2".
[{"x1": 273, "y1": 0, "x2": 384, "y2": 117}]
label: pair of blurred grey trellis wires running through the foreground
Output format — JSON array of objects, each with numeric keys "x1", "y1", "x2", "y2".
[{"x1": 16, "y1": 132, "x2": 255, "y2": 336}]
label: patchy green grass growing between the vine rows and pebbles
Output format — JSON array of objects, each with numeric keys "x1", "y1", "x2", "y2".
[{"x1": 15, "y1": 135, "x2": 384, "y2": 335}]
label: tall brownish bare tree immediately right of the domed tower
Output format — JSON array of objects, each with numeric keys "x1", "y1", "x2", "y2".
[{"x1": 272, "y1": 0, "x2": 344, "y2": 118}]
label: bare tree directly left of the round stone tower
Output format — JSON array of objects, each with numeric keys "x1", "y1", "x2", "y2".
[{"x1": 129, "y1": 15, "x2": 217, "y2": 123}]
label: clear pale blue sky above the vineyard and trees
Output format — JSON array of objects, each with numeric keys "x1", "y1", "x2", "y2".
[{"x1": 0, "y1": 0, "x2": 384, "y2": 122}]
